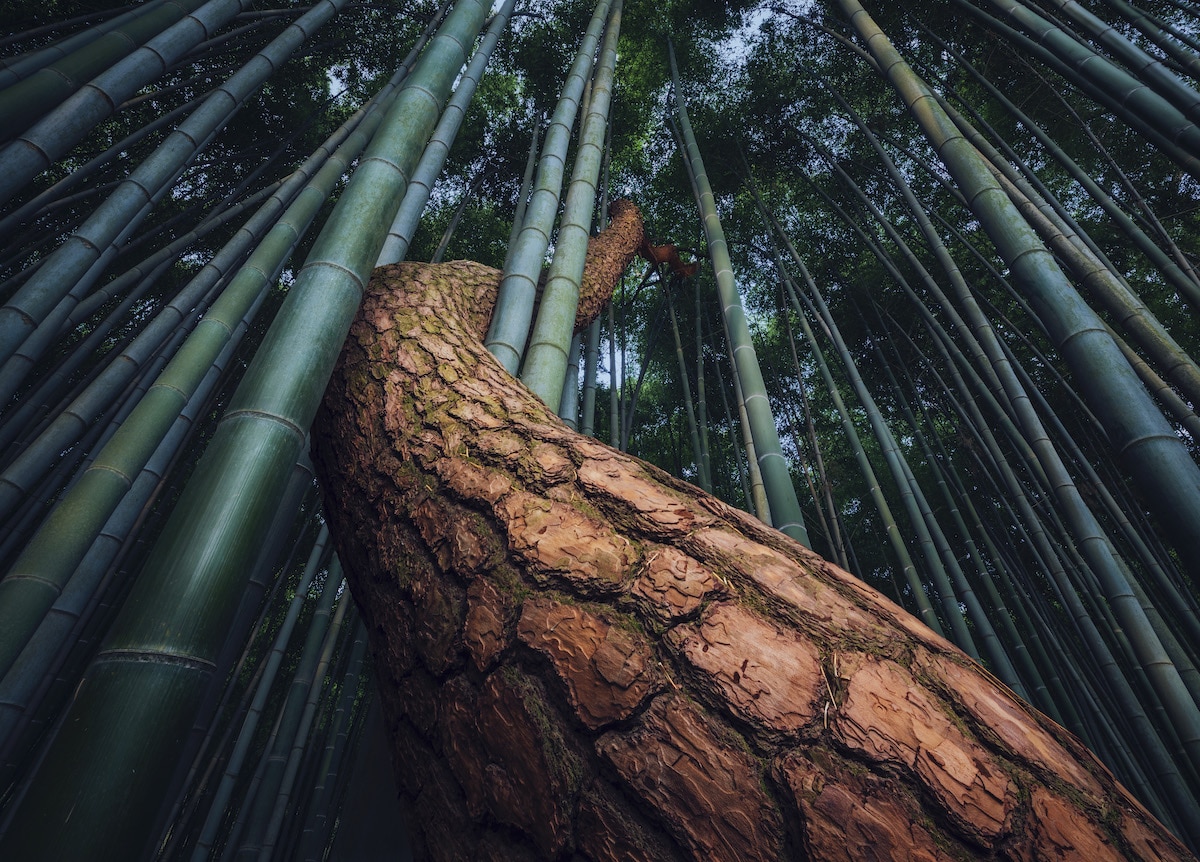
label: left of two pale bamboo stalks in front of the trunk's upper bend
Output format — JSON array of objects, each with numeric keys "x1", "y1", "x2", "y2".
[{"x1": 484, "y1": 0, "x2": 610, "y2": 372}]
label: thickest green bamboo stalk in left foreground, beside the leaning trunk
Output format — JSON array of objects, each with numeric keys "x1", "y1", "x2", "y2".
[{"x1": 0, "y1": 0, "x2": 486, "y2": 858}]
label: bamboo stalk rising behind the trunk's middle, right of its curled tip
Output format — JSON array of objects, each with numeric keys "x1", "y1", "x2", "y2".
[{"x1": 667, "y1": 41, "x2": 809, "y2": 545}]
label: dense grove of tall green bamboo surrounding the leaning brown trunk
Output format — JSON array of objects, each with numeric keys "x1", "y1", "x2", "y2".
[{"x1": 0, "y1": 0, "x2": 1200, "y2": 858}]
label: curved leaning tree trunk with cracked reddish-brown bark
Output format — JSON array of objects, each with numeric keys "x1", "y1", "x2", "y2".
[{"x1": 317, "y1": 203, "x2": 1189, "y2": 862}]
